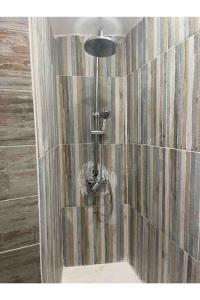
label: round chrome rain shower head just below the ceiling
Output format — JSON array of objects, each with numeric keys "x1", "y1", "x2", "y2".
[{"x1": 84, "y1": 30, "x2": 116, "y2": 57}]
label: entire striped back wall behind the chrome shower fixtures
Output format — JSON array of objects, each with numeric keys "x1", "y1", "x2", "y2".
[{"x1": 56, "y1": 35, "x2": 129, "y2": 266}]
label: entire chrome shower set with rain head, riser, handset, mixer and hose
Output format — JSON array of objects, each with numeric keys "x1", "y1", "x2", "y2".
[{"x1": 84, "y1": 29, "x2": 116, "y2": 216}]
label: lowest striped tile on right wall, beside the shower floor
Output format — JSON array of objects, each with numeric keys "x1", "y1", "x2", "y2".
[{"x1": 130, "y1": 208, "x2": 200, "y2": 283}]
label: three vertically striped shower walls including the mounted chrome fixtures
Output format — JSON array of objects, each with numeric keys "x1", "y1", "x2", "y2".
[{"x1": 27, "y1": 17, "x2": 200, "y2": 283}]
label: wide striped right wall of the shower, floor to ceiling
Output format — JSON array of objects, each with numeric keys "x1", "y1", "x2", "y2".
[{"x1": 126, "y1": 18, "x2": 200, "y2": 283}]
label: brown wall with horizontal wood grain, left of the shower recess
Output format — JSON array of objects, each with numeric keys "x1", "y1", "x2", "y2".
[{"x1": 0, "y1": 17, "x2": 40, "y2": 283}]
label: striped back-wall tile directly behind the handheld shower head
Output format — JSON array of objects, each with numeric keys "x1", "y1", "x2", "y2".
[{"x1": 59, "y1": 76, "x2": 126, "y2": 144}]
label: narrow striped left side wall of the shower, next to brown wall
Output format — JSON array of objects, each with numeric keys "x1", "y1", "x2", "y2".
[{"x1": 29, "y1": 18, "x2": 63, "y2": 282}]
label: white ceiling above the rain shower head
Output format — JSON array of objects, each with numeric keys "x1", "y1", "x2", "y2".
[{"x1": 49, "y1": 17, "x2": 141, "y2": 35}]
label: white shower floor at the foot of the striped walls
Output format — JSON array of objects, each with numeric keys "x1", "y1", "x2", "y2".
[{"x1": 62, "y1": 262, "x2": 142, "y2": 283}]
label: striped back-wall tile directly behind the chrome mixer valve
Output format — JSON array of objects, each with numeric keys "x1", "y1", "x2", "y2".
[{"x1": 62, "y1": 144, "x2": 126, "y2": 206}]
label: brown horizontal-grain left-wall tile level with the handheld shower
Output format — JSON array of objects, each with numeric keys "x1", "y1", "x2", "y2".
[{"x1": 0, "y1": 90, "x2": 35, "y2": 146}]
